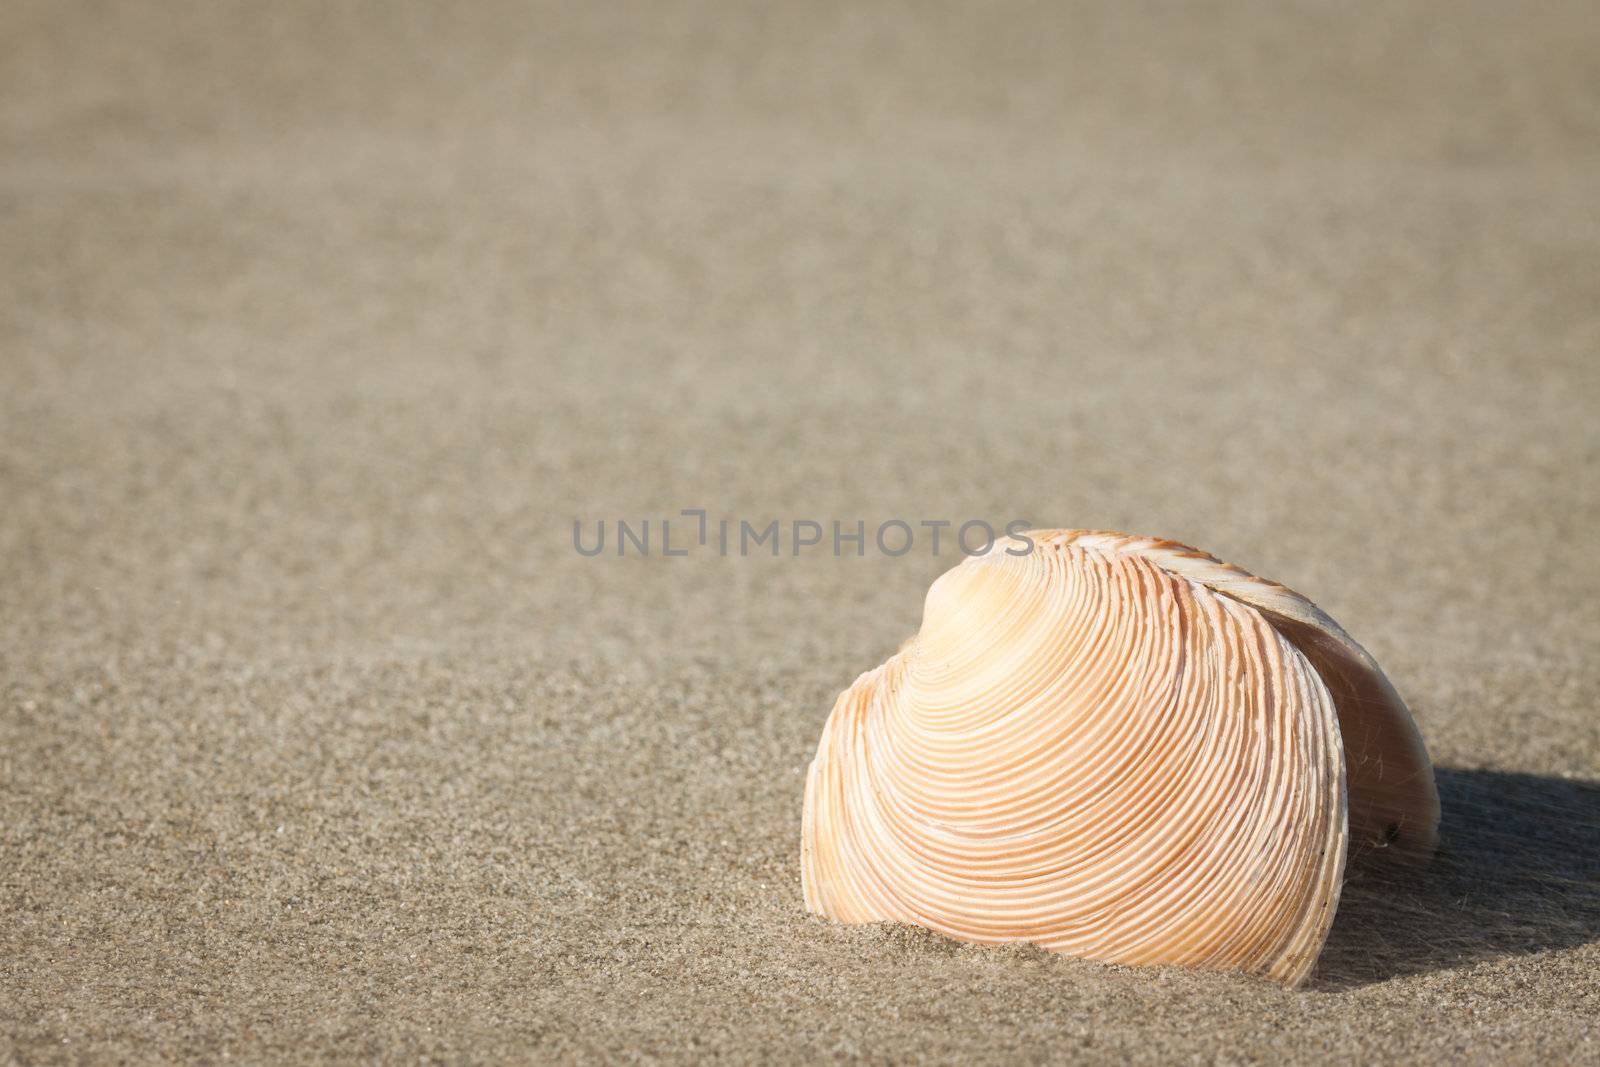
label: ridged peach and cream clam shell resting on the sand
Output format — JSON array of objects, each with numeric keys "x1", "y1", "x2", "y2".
[{"x1": 802, "y1": 530, "x2": 1438, "y2": 985}]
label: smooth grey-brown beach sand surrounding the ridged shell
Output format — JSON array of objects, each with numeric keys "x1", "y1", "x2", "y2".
[{"x1": 0, "y1": 0, "x2": 1600, "y2": 1062}]
